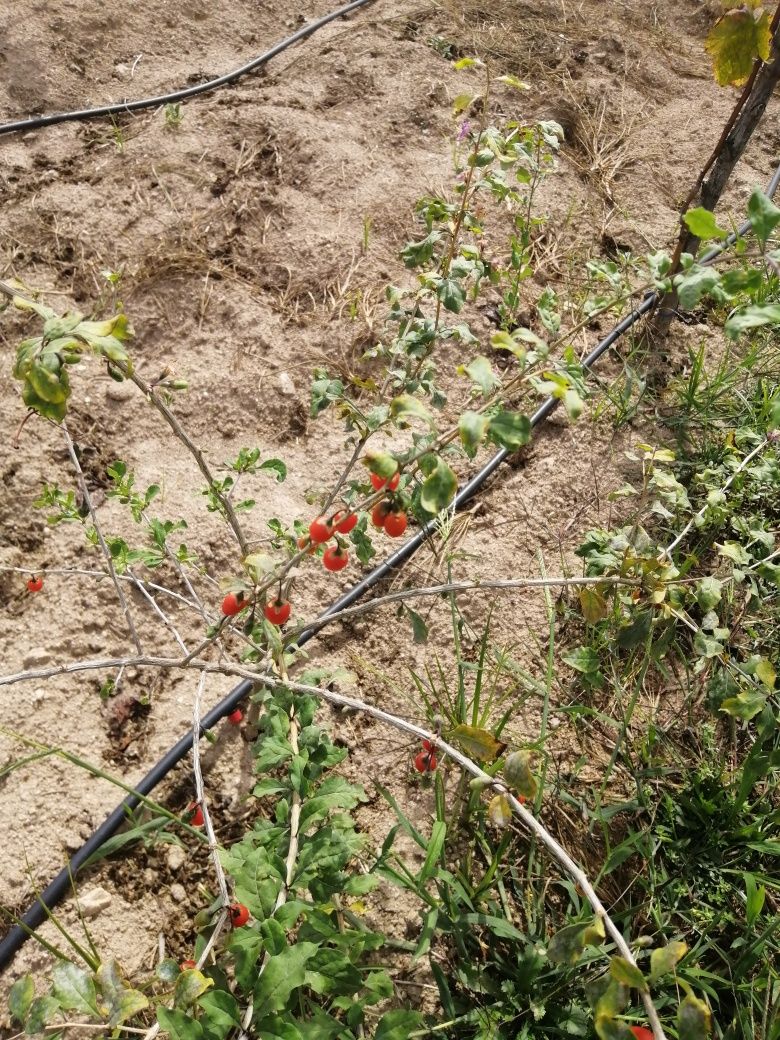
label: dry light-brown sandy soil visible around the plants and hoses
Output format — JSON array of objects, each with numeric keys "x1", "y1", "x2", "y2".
[{"x1": 0, "y1": 0, "x2": 780, "y2": 1019}]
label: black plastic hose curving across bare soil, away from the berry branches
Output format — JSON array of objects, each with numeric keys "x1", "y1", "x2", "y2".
[{"x1": 0, "y1": 0, "x2": 372, "y2": 134}]
